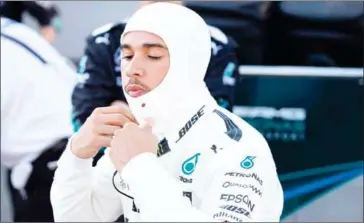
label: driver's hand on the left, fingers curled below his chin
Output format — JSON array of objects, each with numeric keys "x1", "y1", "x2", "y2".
[{"x1": 71, "y1": 104, "x2": 136, "y2": 159}]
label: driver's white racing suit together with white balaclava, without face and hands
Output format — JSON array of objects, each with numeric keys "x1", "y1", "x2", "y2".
[{"x1": 51, "y1": 3, "x2": 283, "y2": 222}]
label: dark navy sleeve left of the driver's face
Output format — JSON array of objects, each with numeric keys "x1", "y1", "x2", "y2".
[{"x1": 72, "y1": 37, "x2": 122, "y2": 131}]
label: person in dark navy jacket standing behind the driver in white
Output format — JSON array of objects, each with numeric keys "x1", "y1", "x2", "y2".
[{"x1": 72, "y1": 1, "x2": 238, "y2": 130}]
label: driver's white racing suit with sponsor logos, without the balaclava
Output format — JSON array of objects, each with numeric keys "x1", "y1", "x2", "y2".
[{"x1": 52, "y1": 101, "x2": 283, "y2": 222}]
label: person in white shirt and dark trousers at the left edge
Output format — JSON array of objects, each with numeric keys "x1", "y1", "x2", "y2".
[{"x1": 1, "y1": 18, "x2": 76, "y2": 222}]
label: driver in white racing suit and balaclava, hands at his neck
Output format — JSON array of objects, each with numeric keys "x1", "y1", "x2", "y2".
[{"x1": 51, "y1": 3, "x2": 283, "y2": 222}]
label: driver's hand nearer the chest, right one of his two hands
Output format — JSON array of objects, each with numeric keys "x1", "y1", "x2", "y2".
[{"x1": 109, "y1": 122, "x2": 158, "y2": 173}]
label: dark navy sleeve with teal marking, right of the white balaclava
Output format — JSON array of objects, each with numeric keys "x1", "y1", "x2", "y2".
[{"x1": 205, "y1": 37, "x2": 239, "y2": 111}]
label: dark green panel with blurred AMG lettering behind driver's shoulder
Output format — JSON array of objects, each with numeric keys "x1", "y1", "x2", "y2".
[{"x1": 235, "y1": 75, "x2": 364, "y2": 174}]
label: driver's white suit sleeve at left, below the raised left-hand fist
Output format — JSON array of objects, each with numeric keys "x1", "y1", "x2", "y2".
[{"x1": 50, "y1": 141, "x2": 123, "y2": 222}]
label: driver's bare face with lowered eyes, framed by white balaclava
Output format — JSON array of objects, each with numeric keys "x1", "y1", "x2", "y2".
[{"x1": 121, "y1": 31, "x2": 169, "y2": 97}]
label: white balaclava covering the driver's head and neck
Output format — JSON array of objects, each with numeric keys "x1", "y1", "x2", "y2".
[{"x1": 121, "y1": 3, "x2": 215, "y2": 137}]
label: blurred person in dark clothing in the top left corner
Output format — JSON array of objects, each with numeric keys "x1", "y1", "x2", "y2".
[{"x1": 0, "y1": 1, "x2": 61, "y2": 43}]
